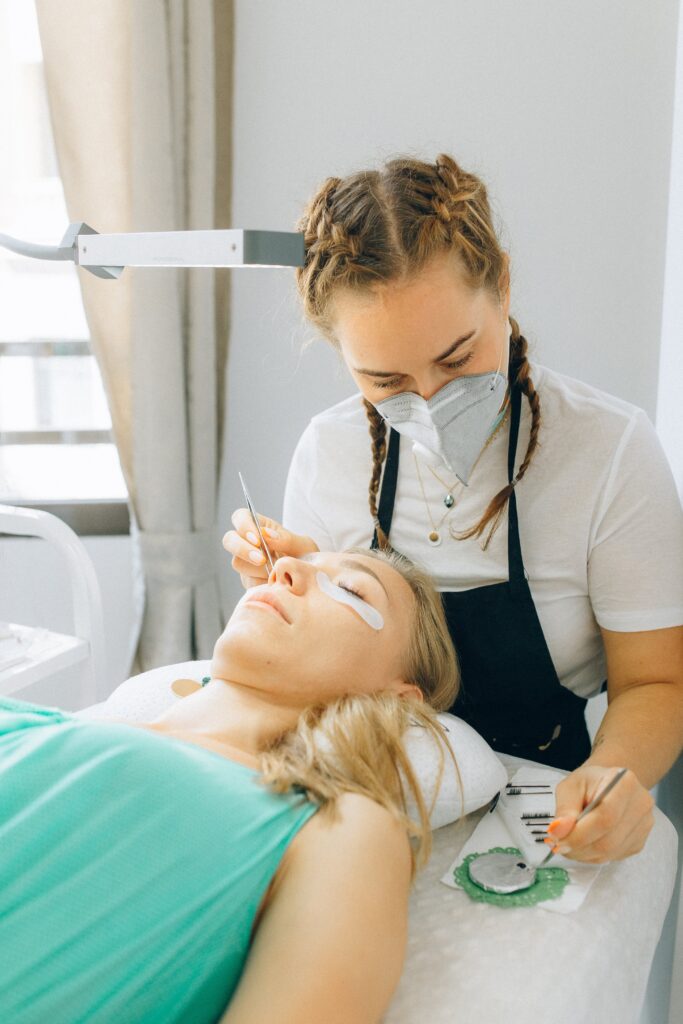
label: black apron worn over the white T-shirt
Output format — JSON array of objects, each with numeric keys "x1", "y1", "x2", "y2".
[{"x1": 372, "y1": 388, "x2": 593, "y2": 771}]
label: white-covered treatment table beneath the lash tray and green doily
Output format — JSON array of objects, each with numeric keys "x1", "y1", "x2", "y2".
[{"x1": 384, "y1": 755, "x2": 678, "y2": 1024}]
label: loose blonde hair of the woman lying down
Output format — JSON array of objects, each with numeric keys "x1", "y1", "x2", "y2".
[{"x1": 259, "y1": 548, "x2": 462, "y2": 879}]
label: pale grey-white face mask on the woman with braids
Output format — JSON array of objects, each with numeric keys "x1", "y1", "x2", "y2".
[{"x1": 375, "y1": 335, "x2": 510, "y2": 484}]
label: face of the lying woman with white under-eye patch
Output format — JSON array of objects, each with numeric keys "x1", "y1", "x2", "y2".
[{"x1": 211, "y1": 552, "x2": 415, "y2": 706}]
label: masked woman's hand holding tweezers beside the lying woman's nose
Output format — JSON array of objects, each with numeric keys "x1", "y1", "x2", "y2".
[{"x1": 223, "y1": 509, "x2": 318, "y2": 588}]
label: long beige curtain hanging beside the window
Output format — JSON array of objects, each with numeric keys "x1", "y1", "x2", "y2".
[{"x1": 37, "y1": 0, "x2": 233, "y2": 671}]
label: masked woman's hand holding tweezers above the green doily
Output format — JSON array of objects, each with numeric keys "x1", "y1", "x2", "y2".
[{"x1": 546, "y1": 765, "x2": 654, "y2": 866}]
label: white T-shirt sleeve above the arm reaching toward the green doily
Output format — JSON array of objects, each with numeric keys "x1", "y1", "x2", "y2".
[{"x1": 588, "y1": 410, "x2": 683, "y2": 633}]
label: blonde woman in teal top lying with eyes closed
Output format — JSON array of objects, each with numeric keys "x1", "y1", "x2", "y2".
[{"x1": 0, "y1": 550, "x2": 458, "y2": 1024}]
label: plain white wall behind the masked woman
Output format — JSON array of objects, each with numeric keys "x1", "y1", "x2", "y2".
[{"x1": 221, "y1": 0, "x2": 678, "y2": 609}]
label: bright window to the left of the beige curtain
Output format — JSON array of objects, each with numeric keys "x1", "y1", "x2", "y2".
[{"x1": 0, "y1": 0, "x2": 127, "y2": 532}]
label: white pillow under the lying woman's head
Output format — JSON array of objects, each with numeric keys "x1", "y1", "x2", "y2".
[{"x1": 74, "y1": 660, "x2": 508, "y2": 828}]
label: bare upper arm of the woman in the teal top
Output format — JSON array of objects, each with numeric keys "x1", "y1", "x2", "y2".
[{"x1": 219, "y1": 794, "x2": 411, "y2": 1024}]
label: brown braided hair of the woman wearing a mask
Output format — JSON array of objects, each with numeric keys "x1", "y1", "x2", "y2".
[{"x1": 297, "y1": 154, "x2": 541, "y2": 549}]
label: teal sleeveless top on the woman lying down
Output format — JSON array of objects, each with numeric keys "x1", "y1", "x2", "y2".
[{"x1": 0, "y1": 696, "x2": 318, "y2": 1024}]
